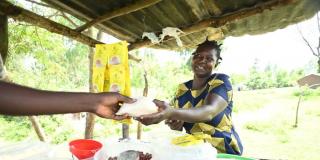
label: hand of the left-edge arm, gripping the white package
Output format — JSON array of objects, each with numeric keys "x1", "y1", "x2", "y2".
[{"x1": 94, "y1": 92, "x2": 136, "y2": 120}]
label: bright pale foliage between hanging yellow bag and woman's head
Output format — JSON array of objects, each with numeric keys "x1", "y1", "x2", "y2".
[{"x1": 130, "y1": 49, "x2": 192, "y2": 101}]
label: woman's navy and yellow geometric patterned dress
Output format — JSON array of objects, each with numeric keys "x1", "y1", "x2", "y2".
[{"x1": 172, "y1": 74, "x2": 243, "y2": 155}]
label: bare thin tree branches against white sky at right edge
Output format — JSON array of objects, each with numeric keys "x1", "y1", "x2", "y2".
[{"x1": 297, "y1": 13, "x2": 320, "y2": 73}]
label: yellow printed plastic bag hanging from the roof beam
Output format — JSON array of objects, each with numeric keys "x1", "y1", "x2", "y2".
[{"x1": 92, "y1": 41, "x2": 131, "y2": 124}]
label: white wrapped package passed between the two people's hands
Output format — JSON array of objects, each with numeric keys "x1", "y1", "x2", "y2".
[{"x1": 116, "y1": 97, "x2": 158, "y2": 117}]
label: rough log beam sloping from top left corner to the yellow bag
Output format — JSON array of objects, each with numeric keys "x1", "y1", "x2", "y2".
[{"x1": 0, "y1": 1, "x2": 140, "y2": 61}]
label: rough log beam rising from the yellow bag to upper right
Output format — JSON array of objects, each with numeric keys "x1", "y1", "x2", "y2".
[{"x1": 129, "y1": 0, "x2": 297, "y2": 50}]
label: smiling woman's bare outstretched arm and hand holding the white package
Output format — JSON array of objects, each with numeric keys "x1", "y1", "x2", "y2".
[{"x1": 137, "y1": 94, "x2": 228, "y2": 125}]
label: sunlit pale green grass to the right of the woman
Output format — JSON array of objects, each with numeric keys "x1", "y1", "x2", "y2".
[{"x1": 233, "y1": 88, "x2": 320, "y2": 160}]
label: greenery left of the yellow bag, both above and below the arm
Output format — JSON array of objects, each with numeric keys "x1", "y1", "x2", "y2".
[{"x1": 0, "y1": 2, "x2": 89, "y2": 143}]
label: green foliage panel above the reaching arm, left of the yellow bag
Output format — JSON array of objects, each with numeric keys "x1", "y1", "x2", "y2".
[{"x1": 6, "y1": 22, "x2": 89, "y2": 90}]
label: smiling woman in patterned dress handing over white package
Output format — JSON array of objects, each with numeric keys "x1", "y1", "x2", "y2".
[{"x1": 138, "y1": 41, "x2": 243, "y2": 155}]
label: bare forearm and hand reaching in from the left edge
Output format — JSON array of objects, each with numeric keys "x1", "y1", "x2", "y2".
[{"x1": 0, "y1": 81, "x2": 135, "y2": 120}]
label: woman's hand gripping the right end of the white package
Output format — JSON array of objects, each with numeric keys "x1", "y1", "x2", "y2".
[{"x1": 135, "y1": 99, "x2": 172, "y2": 125}]
